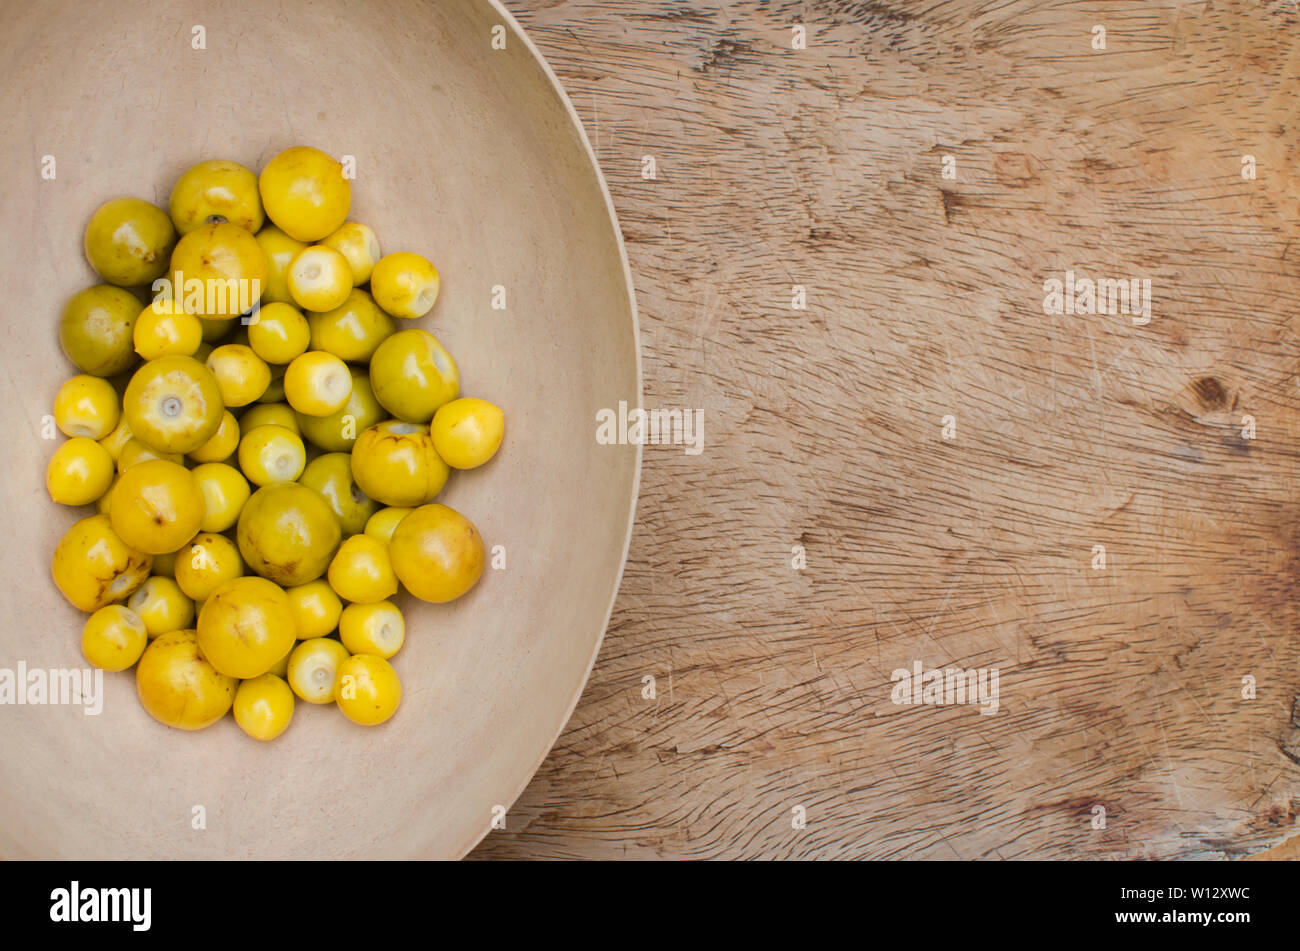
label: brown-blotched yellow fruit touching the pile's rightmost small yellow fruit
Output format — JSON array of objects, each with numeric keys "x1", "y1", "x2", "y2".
[{"x1": 352, "y1": 420, "x2": 451, "y2": 508}]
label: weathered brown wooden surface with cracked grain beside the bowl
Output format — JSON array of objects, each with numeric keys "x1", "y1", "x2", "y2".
[{"x1": 476, "y1": 0, "x2": 1300, "y2": 859}]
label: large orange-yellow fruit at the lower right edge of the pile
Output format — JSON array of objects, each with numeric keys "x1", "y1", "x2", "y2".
[{"x1": 389, "y1": 505, "x2": 484, "y2": 603}]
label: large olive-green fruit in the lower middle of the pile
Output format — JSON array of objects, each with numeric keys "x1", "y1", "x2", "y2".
[{"x1": 237, "y1": 482, "x2": 343, "y2": 587}]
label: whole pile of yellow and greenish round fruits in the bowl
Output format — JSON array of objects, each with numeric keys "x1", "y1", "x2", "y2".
[{"x1": 46, "y1": 147, "x2": 504, "y2": 739}]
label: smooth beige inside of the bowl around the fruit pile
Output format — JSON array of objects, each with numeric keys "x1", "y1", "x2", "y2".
[{"x1": 0, "y1": 0, "x2": 640, "y2": 857}]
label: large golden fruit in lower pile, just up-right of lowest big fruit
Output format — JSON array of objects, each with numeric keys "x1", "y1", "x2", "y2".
[{"x1": 199, "y1": 577, "x2": 298, "y2": 679}]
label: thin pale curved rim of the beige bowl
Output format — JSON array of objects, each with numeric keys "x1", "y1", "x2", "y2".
[{"x1": 456, "y1": 0, "x2": 644, "y2": 859}]
